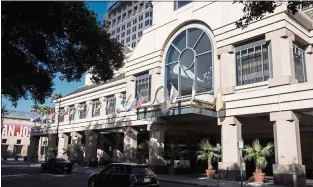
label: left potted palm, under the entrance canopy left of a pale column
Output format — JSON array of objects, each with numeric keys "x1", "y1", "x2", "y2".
[{"x1": 197, "y1": 139, "x2": 221, "y2": 179}]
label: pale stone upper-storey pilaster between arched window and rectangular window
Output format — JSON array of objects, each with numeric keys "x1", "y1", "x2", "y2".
[{"x1": 215, "y1": 45, "x2": 237, "y2": 94}]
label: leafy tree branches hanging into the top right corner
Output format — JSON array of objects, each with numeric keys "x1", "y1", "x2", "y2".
[{"x1": 234, "y1": 0, "x2": 313, "y2": 28}]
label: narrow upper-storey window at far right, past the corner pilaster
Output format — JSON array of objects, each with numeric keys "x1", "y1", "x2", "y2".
[{"x1": 293, "y1": 45, "x2": 306, "y2": 83}]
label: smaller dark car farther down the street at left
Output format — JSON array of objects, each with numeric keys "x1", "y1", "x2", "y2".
[{"x1": 40, "y1": 158, "x2": 73, "y2": 173}]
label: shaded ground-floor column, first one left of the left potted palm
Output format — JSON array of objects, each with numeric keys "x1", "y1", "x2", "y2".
[{"x1": 149, "y1": 123, "x2": 166, "y2": 167}]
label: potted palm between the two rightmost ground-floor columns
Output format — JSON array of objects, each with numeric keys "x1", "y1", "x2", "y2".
[{"x1": 242, "y1": 139, "x2": 274, "y2": 183}]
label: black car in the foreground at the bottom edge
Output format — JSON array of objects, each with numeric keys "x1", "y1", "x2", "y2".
[{"x1": 88, "y1": 163, "x2": 160, "y2": 187}]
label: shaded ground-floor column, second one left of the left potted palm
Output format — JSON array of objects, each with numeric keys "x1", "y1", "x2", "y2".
[{"x1": 123, "y1": 127, "x2": 138, "y2": 162}]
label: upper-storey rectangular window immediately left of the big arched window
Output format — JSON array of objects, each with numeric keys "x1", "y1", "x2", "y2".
[{"x1": 136, "y1": 73, "x2": 151, "y2": 102}]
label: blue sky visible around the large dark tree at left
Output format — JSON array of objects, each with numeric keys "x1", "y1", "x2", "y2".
[{"x1": 1, "y1": 1, "x2": 109, "y2": 112}]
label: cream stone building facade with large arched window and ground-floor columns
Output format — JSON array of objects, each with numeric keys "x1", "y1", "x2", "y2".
[{"x1": 32, "y1": 1, "x2": 313, "y2": 186}]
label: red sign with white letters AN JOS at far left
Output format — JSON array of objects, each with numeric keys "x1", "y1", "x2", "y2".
[{"x1": 2, "y1": 124, "x2": 32, "y2": 137}]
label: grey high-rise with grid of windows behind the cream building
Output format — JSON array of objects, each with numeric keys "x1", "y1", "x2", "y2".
[{"x1": 104, "y1": 1, "x2": 153, "y2": 48}]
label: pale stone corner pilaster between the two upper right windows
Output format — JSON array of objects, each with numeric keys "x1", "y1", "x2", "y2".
[{"x1": 265, "y1": 28, "x2": 297, "y2": 87}]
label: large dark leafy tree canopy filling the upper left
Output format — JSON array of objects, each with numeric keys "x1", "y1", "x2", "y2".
[{"x1": 1, "y1": 1, "x2": 124, "y2": 106}]
